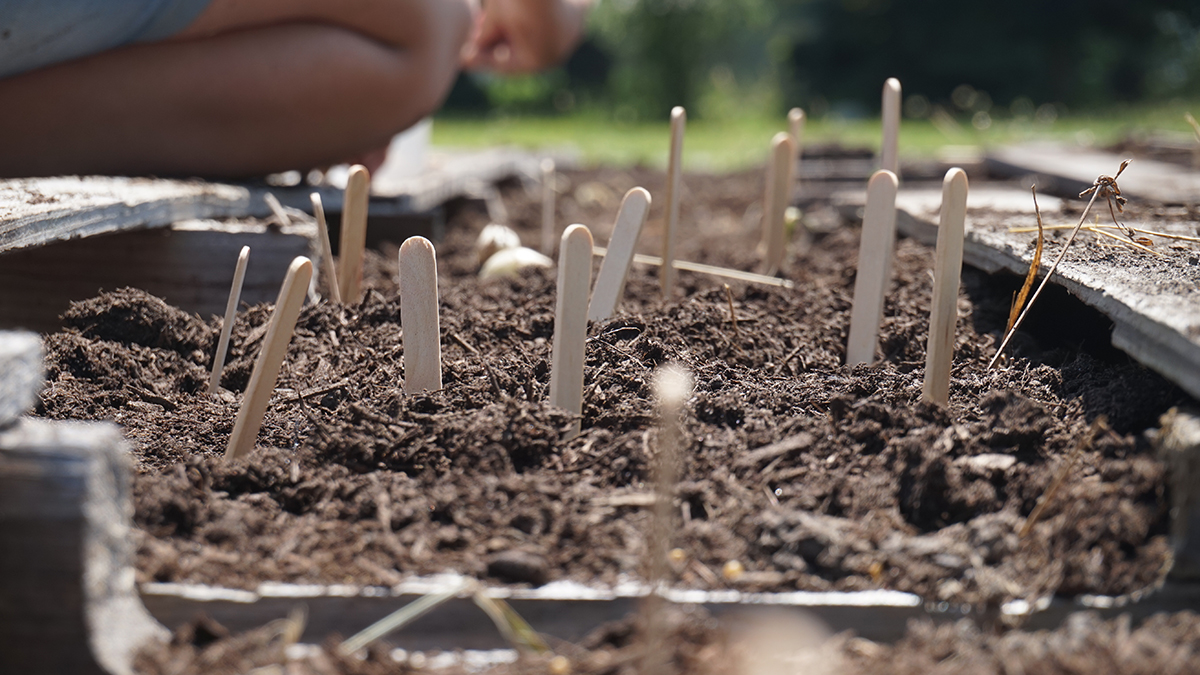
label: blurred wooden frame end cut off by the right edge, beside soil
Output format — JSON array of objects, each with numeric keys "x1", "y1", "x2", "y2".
[{"x1": 1154, "y1": 410, "x2": 1200, "y2": 581}]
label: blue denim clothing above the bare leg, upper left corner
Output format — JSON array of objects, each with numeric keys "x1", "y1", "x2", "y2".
[{"x1": 0, "y1": 0, "x2": 210, "y2": 77}]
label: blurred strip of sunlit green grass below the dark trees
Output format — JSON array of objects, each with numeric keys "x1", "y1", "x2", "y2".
[{"x1": 433, "y1": 101, "x2": 1200, "y2": 172}]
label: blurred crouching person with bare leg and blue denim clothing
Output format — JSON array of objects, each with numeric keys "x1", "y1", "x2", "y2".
[{"x1": 0, "y1": 0, "x2": 592, "y2": 177}]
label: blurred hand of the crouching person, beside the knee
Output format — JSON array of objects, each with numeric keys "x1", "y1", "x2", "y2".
[{"x1": 462, "y1": 0, "x2": 590, "y2": 73}]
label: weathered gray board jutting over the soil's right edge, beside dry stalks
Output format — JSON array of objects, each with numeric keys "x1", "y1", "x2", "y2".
[{"x1": 888, "y1": 183, "x2": 1200, "y2": 398}]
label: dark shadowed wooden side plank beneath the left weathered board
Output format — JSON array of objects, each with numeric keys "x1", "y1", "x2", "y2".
[{"x1": 0, "y1": 221, "x2": 318, "y2": 331}]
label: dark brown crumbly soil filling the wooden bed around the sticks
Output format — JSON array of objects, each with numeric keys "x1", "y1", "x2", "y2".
[{"x1": 32, "y1": 171, "x2": 1184, "y2": 605}]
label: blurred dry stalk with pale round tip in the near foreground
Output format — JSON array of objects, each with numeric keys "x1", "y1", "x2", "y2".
[{"x1": 641, "y1": 364, "x2": 692, "y2": 675}]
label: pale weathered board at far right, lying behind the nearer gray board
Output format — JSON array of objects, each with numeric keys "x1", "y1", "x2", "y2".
[{"x1": 988, "y1": 144, "x2": 1200, "y2": 204}]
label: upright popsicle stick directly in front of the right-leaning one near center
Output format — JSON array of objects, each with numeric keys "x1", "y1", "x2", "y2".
[{"x1": 550, "y1": 225, "x2": 592, "y2": 436}]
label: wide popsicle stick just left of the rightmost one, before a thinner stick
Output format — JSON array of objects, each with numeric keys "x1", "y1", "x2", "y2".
[{"x1": 846, "y1": 169, "x2": 899, "y2": 365}]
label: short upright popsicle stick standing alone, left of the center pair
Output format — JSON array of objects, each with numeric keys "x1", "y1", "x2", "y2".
[{"x1": 400, "y1": 237, "x2": 442, "y2": 394}]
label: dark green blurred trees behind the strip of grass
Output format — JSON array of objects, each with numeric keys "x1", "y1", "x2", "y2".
[{"x1": 448, "y1": 0, "x2": 1200, "y2": 121}]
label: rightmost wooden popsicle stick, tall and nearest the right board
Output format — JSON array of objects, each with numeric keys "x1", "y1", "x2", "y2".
[{"x1": 922, "y1": 167, "x2": 967, "y2": 405}]
